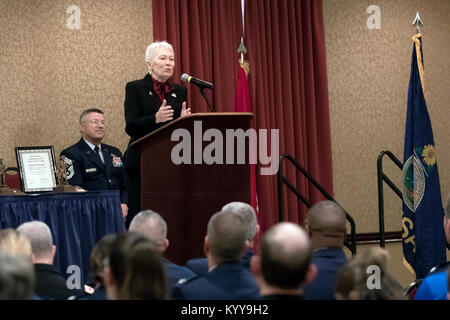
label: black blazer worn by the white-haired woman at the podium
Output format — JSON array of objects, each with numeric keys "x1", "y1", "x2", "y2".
[{"x1": 124, "y1": 74, "x2": 187, "y2": 171}]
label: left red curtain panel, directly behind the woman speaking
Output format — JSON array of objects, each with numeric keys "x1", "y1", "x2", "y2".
[{"x1": 152, "y1": 0, "x2": 242, "y2": 112}]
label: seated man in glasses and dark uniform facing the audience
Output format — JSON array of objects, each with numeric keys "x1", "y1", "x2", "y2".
[{"x1": 61, "y1": 109, "x2": 128, "y2": 218}]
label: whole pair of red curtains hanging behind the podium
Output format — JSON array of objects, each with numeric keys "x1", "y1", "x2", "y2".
[{"x1": 153, "y1": 0, "x2": 333, "y2": 230}]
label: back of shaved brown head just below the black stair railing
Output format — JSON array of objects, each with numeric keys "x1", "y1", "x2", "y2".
[{"x1": 305, "y1": 200, "x2": 346, "y2": 247}]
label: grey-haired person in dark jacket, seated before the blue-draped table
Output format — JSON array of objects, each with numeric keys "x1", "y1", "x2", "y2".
[{"x1": 17, "y1": 221, "x2": 83, "y2": 300}]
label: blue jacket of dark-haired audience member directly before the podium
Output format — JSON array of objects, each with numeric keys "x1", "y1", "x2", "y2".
[{"x1": 172, "y1": 263, "x2": 259, "y2": 300}]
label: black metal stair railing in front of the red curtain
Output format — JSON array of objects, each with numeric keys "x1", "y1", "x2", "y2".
[{"x1": 277, "y1": 154, "x2": 356, "y2": 255}]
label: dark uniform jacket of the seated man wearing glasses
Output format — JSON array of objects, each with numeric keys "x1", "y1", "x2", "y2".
[{"x1": 61, "y1": 139, "x2": 128, "y2": 203}]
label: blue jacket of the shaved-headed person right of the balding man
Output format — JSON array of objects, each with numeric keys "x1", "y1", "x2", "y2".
[{"x1": 303, "y1": 247, "x2": 347, "y2": 300}]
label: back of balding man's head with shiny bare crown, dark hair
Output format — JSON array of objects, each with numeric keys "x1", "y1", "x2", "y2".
[{"x1": 252, "y1": 222, "x2": 317, "y2": 300}]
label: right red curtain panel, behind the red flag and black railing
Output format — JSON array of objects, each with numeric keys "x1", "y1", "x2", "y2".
[{"x1": 245, "y1": 0, "x2": 333, "y2": 229}]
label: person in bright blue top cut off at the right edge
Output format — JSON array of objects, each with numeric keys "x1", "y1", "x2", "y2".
[{"x1": 414, "y1": 194, "x2": 450, "y2": 300}]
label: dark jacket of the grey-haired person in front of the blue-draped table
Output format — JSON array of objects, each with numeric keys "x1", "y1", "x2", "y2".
[{"x1": 34, "y1": 263, "x2": 84, "y2": 300}]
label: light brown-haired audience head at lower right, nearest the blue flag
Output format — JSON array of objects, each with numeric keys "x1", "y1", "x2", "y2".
[{"x1": 336, "y1": 247, "x2": 405, "y2": 300}]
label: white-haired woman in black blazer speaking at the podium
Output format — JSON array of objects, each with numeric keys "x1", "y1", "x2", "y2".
[{"x1": 124, "y1": 41, "x2": 191, "y2": 227}]
